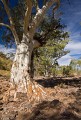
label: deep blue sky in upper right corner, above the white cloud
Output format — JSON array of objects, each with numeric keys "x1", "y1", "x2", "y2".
[{"x1": 61, "y1": 0, "x2": 81, "y2": 40}]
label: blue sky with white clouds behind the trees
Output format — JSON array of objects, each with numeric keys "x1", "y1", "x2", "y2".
[{"x1": 0, "y1": 0, "x2": 81, "y2": 65}]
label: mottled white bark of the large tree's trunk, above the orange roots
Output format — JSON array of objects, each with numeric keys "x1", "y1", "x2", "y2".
[{"x1": 11, "y1": 35, "x2": 33, "y2": 92}]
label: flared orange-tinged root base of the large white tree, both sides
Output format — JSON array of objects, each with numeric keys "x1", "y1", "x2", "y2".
[{"x1": 6, "y1": 80, "x2": 47, "y2": 104}]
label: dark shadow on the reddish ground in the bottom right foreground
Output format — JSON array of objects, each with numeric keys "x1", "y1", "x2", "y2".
[{"x1": 27, "y1": 99, "x2": 81, "y2": 120}]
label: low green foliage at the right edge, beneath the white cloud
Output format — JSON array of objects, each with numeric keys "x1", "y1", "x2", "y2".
[{"x1": 57, "y1": 59, "x2": 81, "y2": 77}]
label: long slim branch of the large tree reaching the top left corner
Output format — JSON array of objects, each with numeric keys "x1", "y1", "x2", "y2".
[{"x1": 1, "y1": 0, "x2": 19, "y2": 44}]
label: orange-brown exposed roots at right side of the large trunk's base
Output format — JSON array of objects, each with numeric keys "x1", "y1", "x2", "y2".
[{"x1": 27, "y1": 81, "x2": 47, "y2": 102}]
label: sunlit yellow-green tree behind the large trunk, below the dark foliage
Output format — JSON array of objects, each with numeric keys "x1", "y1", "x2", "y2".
[{"x1": 34, "y1": 34, "x2": 68, "y2": 76}]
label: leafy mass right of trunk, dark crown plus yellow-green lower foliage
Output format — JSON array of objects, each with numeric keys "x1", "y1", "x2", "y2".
[{"x1": 34, "y1": 16, "x2": 69, "y2": 76}]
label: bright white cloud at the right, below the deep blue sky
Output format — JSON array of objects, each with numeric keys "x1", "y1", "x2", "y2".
[{"x1": 58, "y1": 41, "x2": 81, "y2": 65}]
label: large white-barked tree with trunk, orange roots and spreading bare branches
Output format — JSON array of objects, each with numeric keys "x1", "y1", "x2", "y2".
[{"x1": 0, "y1": 0, "x2": 60, "y2": 100}]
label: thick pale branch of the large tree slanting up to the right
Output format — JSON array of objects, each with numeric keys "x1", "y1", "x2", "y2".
[{"x1": 30, "y1": 0, "x2": 60, "y2": 34}]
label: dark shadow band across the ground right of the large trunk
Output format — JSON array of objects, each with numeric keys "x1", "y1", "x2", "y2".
[{"x1": 36, "y1": 77, "x2": 81, "y2": 87}]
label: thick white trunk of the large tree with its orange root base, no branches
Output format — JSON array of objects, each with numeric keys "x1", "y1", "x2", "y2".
[{"x1": 10, "y1": 36, "x2": 45, "y2": 101}]
